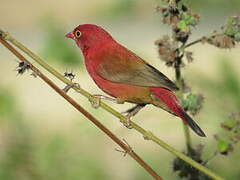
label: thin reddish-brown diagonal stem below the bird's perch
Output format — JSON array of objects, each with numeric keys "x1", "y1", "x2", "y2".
[{"x1": 0, "y1": 38, "x2": 163, "y2": 180}]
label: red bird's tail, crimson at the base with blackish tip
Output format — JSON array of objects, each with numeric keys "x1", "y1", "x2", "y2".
[{"x1": 151, "y1": 87, "x2": 206, "y2": 137}]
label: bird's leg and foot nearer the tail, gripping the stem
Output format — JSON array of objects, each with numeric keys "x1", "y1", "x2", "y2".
[{"x1": 121, "y1": 104, "x2": 146, "y2": 129}]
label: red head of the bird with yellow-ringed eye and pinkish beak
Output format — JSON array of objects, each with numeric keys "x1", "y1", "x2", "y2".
[{"x1": 66, "y1": 24, "x2": 113, "y2": 51}]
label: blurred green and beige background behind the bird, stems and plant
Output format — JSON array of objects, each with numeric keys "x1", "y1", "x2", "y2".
[{"x1": 0, "y1": 0, "x2": 240, "y2": 180}]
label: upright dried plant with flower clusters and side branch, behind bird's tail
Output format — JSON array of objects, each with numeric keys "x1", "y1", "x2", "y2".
[{"x1": 155, "y1": 0, "x2": 240, "y2": 180}]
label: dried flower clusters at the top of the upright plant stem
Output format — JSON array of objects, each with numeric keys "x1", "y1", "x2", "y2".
[{"x1": 155, "y1": 0, "x2": 200, "y2": 67}]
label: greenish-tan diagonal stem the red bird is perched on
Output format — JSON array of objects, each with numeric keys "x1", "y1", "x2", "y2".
[{"x1": 0, "y1": 31, "x2": 223, "y2": 180}]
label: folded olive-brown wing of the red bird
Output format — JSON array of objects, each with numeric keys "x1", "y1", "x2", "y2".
[{"x1": 95, "y1": 44, "x2": 178, "y2": 90}]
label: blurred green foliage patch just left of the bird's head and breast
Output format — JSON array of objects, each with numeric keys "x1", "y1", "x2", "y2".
[{"x1": 42, "y1": 20, "x2": 81, "y2": 67}]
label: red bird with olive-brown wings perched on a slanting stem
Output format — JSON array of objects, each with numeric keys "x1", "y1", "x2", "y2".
[{"x1": 66, "y1": 24, "x2": 205, "y2": 136}]
